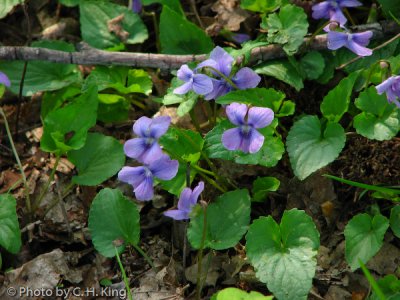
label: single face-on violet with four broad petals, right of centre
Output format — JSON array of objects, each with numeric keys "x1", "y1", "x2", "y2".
[{"x1": 222, "y1": 103, "x2": 274, "y2": 153}]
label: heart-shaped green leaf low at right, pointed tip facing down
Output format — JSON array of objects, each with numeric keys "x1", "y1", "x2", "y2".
[{"x1": 344, "y1": 214, "x2": 389, "y2": 271}]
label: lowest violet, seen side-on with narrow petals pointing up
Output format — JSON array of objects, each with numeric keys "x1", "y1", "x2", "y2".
[{"x1": 164, "y1": 181, "x2": 204, "y2": 220}]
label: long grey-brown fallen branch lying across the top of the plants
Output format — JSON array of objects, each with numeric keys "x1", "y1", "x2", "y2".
[{"x1": 0, "y1": 21, "x2": 400, "y2": 70}]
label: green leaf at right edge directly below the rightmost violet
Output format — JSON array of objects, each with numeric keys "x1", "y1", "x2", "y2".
[{"x1": 354, "y1": 86, "x2": 400, "y2": 141}]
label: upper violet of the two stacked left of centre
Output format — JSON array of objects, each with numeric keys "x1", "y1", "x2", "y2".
[{"x1": 124, "y1": 116, "x2": 171, "y2": 164}]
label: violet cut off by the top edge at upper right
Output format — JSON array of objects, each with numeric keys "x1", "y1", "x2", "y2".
[{"x1": 312, "y1": 0, "x2": 362, "y2": 26}]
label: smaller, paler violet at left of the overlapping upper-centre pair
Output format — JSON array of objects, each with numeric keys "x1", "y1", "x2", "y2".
[{"x1": 174, "y1": 65, "x2": 213, "y2": 95}]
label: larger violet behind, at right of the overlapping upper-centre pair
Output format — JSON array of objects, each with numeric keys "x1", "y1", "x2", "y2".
[{"x1": 197, "y1": 47, "x2": 261, "y2": 100}]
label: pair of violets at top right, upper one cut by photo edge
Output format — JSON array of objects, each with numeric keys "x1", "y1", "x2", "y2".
[{"x1": 312, "y1": 0, "x2": 372, "y2": 56}]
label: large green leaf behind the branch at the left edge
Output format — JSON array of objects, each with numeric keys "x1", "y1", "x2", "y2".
[{"x1": 0, "y1": 41, "x2": 82, "y2": 96}]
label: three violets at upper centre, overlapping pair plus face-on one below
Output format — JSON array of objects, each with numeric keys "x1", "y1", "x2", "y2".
[{"x1": 174, "y1": 47, "x2": 274, "y2": 153}]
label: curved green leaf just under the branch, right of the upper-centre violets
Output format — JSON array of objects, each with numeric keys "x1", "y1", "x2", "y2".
[{"x1": 254, "y1": 59, "x2": 304, "y2": 91}]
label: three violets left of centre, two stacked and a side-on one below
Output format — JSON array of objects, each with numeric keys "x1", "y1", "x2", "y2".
[{"x1": 118, "y1": 116, "x2": 204, "y2": 220}]
